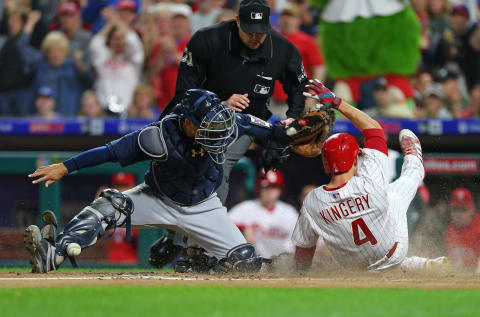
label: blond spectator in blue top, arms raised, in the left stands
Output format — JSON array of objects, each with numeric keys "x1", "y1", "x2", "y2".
[{"x1": 34, "y1": 31, "x2": 93, "y2": 117}]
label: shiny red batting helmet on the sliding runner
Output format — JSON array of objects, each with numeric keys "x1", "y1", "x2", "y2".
[{"x1": 322, "y1": 133, "x2": 362, "y2": 174}]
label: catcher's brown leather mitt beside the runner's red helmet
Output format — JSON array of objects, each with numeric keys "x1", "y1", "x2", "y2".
[{"x1": 290, "y1": 104, "x2": 335, "y2": 157}]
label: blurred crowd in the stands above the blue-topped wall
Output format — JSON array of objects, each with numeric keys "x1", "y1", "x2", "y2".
[{"x1": 0, "y1": 0, "x2": 480, "y2": 119}]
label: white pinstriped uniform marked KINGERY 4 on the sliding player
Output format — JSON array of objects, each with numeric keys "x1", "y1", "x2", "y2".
[{"x1": 292, "y1": 130, "x2": 423, "y2": 269}]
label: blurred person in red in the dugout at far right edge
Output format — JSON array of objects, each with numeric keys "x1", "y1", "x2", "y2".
[{"x1": 446, "y1": 188, "x2": 480, "y2": 269}]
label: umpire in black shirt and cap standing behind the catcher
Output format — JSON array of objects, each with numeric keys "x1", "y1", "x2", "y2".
[{"x1": 159, "y1": 0, "x2": 308, "y2": 202}]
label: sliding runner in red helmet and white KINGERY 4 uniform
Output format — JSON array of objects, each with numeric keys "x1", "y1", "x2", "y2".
[{"x1": 292, "y1": 80, "x2": 447, "y2": 271}]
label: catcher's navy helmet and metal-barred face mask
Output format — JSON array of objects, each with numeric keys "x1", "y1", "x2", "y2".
[{"x1": 181, "y1": 89, "x2": 238, "y2": 164}]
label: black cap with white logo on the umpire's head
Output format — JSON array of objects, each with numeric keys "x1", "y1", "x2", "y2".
[{"x1": 238, "y1": 0, "x2": 271, "y2": 34}]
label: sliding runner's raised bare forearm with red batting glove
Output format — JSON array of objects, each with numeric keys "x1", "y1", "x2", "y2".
[{"x1": 303, "y1": 79, "x2": 382, "y2": 131}]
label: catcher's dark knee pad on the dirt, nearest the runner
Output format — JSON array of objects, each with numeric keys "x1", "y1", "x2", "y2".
[{"x1": 218, "y1": 243, "x2": 270, "y2": 273}]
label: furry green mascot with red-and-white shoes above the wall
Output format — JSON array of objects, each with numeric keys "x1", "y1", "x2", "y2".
[{"x1": 311, "y1": 0, "x2": 421, "y2": 115}]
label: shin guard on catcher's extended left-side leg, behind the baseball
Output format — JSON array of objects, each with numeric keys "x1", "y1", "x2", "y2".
[{"x1": 56, "y1": 189, "x2": 134, "y2": 266}]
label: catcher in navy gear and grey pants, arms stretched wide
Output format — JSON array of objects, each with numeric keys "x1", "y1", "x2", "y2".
[{"x1": 24, "y1": 89, "x2": 323, "y2": 273}]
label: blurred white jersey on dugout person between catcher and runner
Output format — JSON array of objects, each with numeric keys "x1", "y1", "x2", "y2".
[{"x1": 229, "y1": 199, "x2": 298, "y2": 258}]
